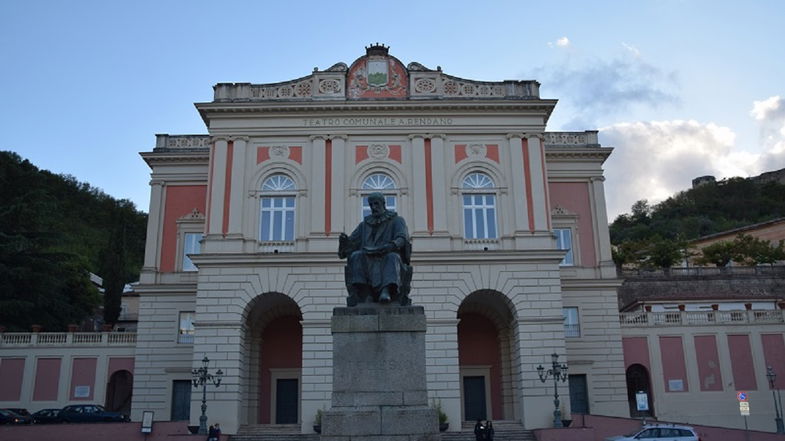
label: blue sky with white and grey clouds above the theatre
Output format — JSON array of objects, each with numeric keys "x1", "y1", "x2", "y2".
[{"x1": 0, "y1": 0, "x2": 785, "y2": 219}]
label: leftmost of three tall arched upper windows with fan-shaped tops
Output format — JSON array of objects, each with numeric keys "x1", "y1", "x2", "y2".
[{"x1": 259, "y1": 175, "x2": 297, "y2": 242}]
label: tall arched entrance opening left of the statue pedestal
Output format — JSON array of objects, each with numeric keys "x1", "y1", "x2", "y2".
[{"x1": 245, "y1": 292, "x2": 303, "y2": 424}]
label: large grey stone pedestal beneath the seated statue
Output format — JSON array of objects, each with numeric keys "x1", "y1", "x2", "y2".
[{"x1": 321, "y1": 304, "x2": 441, "y2": 441}]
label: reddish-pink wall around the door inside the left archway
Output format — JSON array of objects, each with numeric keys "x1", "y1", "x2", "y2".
[{"x1": 259, "y1": 316, "x2": 303, "y2": 424}]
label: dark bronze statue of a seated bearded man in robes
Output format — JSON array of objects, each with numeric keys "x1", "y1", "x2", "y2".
[{"x1": 338, "y1": 193, "x2": 412, "y2": 306}]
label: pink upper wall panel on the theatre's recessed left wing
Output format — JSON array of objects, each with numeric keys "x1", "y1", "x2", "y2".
[{"x1": 160, "y1": 185, "x2": 207, "y2": 272}]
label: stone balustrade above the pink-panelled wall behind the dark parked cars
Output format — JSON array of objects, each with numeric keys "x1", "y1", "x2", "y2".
[{"x1": 0, "y1": 332, "x2": 136, "y2": 347}]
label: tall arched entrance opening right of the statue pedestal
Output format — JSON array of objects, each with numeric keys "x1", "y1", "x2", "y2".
[{"x1": 458, "y1": 290, "x2": 519, "y2": 421}]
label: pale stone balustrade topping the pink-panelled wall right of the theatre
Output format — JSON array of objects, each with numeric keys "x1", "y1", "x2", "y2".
[{"x1": 619, "y1": 309, "x2": 785, "y2": 328}]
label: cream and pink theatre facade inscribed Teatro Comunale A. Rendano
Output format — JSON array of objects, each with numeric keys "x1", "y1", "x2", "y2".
[{"x1": 132, "y1": 44, "x2": 629, "y2": 433}]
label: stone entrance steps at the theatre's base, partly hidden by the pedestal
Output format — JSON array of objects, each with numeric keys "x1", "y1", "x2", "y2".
[{"x1": 229, "y1": 421, "x2": 536, "y2": 441}]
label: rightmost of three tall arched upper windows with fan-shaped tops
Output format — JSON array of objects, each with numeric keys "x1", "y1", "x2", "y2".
[{"x1": 461, "y1": 173, "x2": 498, "y2": 239}]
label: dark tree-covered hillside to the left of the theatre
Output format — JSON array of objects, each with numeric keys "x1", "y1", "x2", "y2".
[{"x1": 0, "y1": 152, "x2": 147, "y2": 331}]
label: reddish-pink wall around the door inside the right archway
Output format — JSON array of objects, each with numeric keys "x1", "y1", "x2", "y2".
[{"x1": 458, "y1": 313, "x2": 506, "y2": 420}]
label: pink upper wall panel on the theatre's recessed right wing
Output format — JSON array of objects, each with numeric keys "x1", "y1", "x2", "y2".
[{"x1": 548, "y1": 182, "x2": 597, "y2": 266}]
